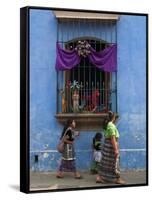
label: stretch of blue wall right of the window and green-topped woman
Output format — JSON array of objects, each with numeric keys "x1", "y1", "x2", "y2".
[{"x1": 117, "y1": 16, "x2": 146, "y2": 168}]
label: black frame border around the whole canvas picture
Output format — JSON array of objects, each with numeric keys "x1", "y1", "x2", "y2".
[{"x1": 20, "y1": 6, "x2": 149, "y2": 193}]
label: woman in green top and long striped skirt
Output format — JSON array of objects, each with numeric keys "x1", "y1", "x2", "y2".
[{"x1": 96, "y1": 111, "x2": 125, "y2": 184}]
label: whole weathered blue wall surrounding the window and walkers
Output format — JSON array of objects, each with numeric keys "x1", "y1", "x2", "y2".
[{"x1": 30, "y1": 9, "x2": 146, "y2": 171}]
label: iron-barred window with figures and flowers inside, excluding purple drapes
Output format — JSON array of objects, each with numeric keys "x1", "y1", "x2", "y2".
[{"x1": 57, "y1": 19, "x2": 117, "y2": 118}]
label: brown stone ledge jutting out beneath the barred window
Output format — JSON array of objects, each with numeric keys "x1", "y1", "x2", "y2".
[{"x1": 55, "y1": 113, "x2": 108, "y2": 131}]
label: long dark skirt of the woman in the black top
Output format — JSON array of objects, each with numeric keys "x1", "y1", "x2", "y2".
[{"x1": 59, "y1": 144, "x2": 76, "y2": 172}]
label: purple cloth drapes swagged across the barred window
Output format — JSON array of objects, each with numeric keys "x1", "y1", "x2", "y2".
[{"x1": 56, "y1": 43, "x2": 117, "y2": 72}]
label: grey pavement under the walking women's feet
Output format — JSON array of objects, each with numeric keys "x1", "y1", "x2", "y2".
[{"x1": 30, "y1": 170, "x2": 147, "y2": 191}]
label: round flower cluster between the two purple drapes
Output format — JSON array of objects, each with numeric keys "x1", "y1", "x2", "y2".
[{"x1": 75, "y1": 40, "x2": 91, "y2": 57}]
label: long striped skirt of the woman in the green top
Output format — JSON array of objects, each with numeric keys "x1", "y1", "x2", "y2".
[{"x1": 98, "y1": 139, "x2": 120, "y2": 182}]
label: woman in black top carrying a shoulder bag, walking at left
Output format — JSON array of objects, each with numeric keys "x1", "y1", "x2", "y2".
[{"x1": 56, "y1": 119, "x2": 82, "y2": 179}]
